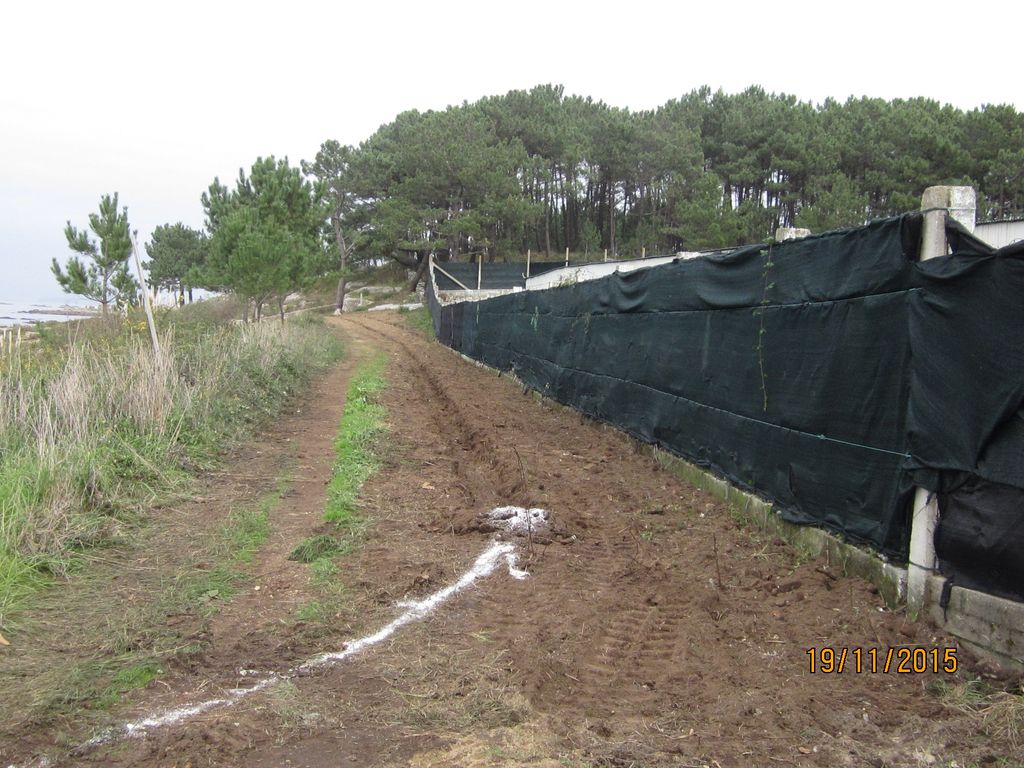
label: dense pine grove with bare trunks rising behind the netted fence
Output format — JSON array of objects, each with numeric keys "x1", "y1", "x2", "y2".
[{"x1": 351, "y1": 86, "x2": 1024, "y2": 268}]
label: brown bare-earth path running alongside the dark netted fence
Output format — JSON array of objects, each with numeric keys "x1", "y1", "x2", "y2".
[{"x1": 4, "y1": 314, "x2": 1021, "y2": 768}]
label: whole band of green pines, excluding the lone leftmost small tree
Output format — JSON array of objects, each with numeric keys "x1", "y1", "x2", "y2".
[{"x1": 55, "y1": 85, "x2": 1024, "y2": 313}]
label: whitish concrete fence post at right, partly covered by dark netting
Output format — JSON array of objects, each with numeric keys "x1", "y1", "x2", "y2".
[{"x1": 906, "y1": 186, "x2": 977, "y2": 612}]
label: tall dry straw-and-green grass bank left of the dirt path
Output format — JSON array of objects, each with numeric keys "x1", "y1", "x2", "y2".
[{"x1": 0, "y1": 322, "x2": 337, "y2": 625}]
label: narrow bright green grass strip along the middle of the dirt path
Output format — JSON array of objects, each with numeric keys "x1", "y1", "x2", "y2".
[{"x1": 324, "y1": 352, "x2": 387, "y2": 529}]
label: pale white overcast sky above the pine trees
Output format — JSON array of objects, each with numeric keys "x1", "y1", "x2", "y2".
[{"x1": 0, "y1": 0, "x2": 1024, "y2": 301}]
